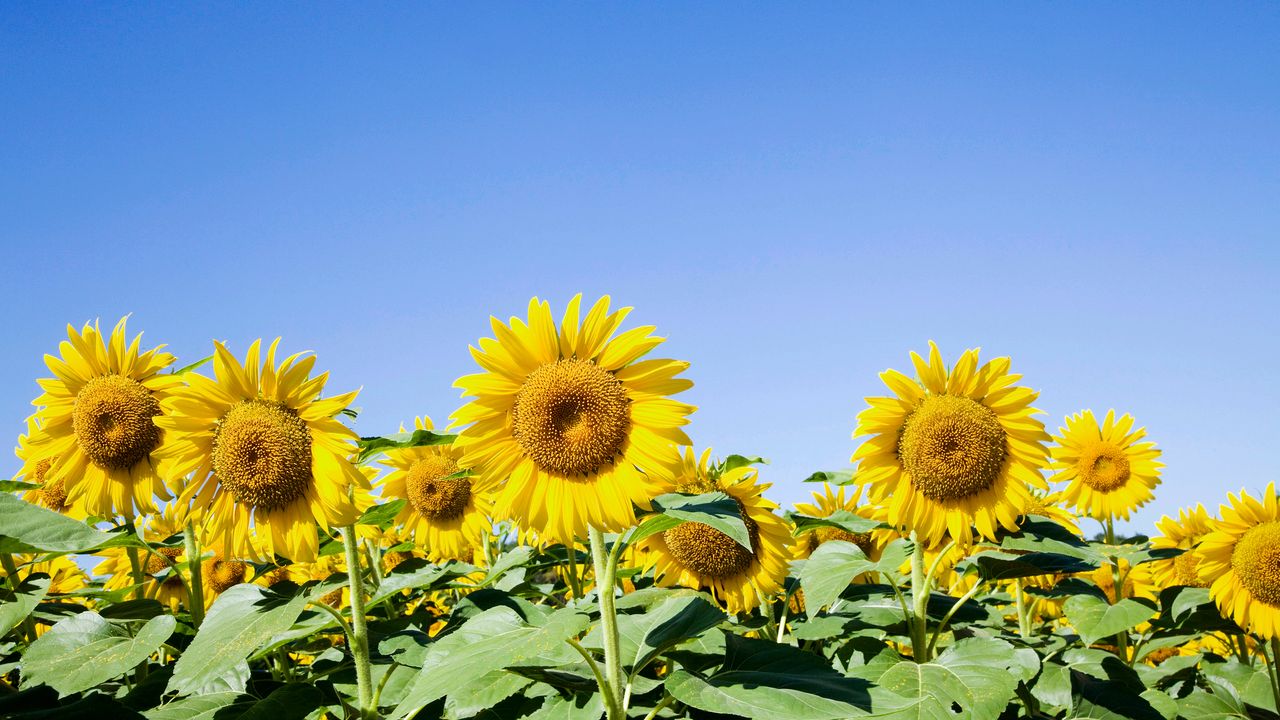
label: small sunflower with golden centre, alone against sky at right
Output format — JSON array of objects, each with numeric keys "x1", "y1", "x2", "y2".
[{"x1": 1050, "y1": 410, "x2": 1164, "y2": 521}]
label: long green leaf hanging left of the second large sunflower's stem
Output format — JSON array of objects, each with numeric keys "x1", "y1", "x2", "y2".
[{"x1": 169, "y1": 583, "x2": 307, "y2": 694}]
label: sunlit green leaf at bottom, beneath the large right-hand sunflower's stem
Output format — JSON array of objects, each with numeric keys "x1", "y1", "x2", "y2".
[{"x1": 878, "y1": 638, "x2": 1018, "y2": 720}]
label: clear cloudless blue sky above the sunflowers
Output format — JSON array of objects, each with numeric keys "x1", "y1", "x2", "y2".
[{"x1": 0, "y1": 3, "x2": 1280, "y2": 530}]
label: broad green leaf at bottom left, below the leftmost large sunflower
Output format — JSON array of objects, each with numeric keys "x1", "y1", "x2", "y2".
[{"x1": 22, "y1": 611, "x2": 178, "y2": 697}]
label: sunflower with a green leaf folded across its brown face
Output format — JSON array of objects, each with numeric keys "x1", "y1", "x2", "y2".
[{"x1": 639, "y1": 448, "x2": 792, "y2": 612}]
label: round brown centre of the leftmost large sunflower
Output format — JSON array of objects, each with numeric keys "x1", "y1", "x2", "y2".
[{"x1": 72, "y1": 375, "x2": 160, "y2": 470}]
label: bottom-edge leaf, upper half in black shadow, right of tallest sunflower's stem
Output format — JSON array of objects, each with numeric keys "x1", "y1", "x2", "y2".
[{"x1": 666, "y1": 633, "x2": 902, "y2": 720}]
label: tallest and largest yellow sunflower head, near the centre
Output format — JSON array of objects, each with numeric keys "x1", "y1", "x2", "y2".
[{"x1": 453, "y1": 295, "x2": 694, "y2": 544}]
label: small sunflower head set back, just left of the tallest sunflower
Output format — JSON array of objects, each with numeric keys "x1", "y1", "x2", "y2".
[{"x1": 381, "y1": 418, "x2": 493, "y2": 561}]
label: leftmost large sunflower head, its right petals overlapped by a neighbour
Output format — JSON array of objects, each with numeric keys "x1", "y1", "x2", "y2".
[{"x1": 19, "y1": 318, "x2": 182, "y2": 518}]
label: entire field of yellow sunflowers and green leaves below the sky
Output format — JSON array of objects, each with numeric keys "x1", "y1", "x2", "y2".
[{"x1": 0, "y1": 297, "x2": 1280, "y2": 720}]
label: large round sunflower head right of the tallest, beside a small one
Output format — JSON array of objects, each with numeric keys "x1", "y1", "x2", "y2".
[{"x1": 852, "y1": 342, "x2": 1048, "y2": 546}]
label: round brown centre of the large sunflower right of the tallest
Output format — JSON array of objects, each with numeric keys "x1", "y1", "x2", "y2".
[{"x1": 897, "y1": 395, "x2": 1007, "y2": 502}]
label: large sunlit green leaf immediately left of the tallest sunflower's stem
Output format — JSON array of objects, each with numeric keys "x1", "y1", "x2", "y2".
[{"x1": 392, "y1": 606, "x2": 590, "y2": 717}]
